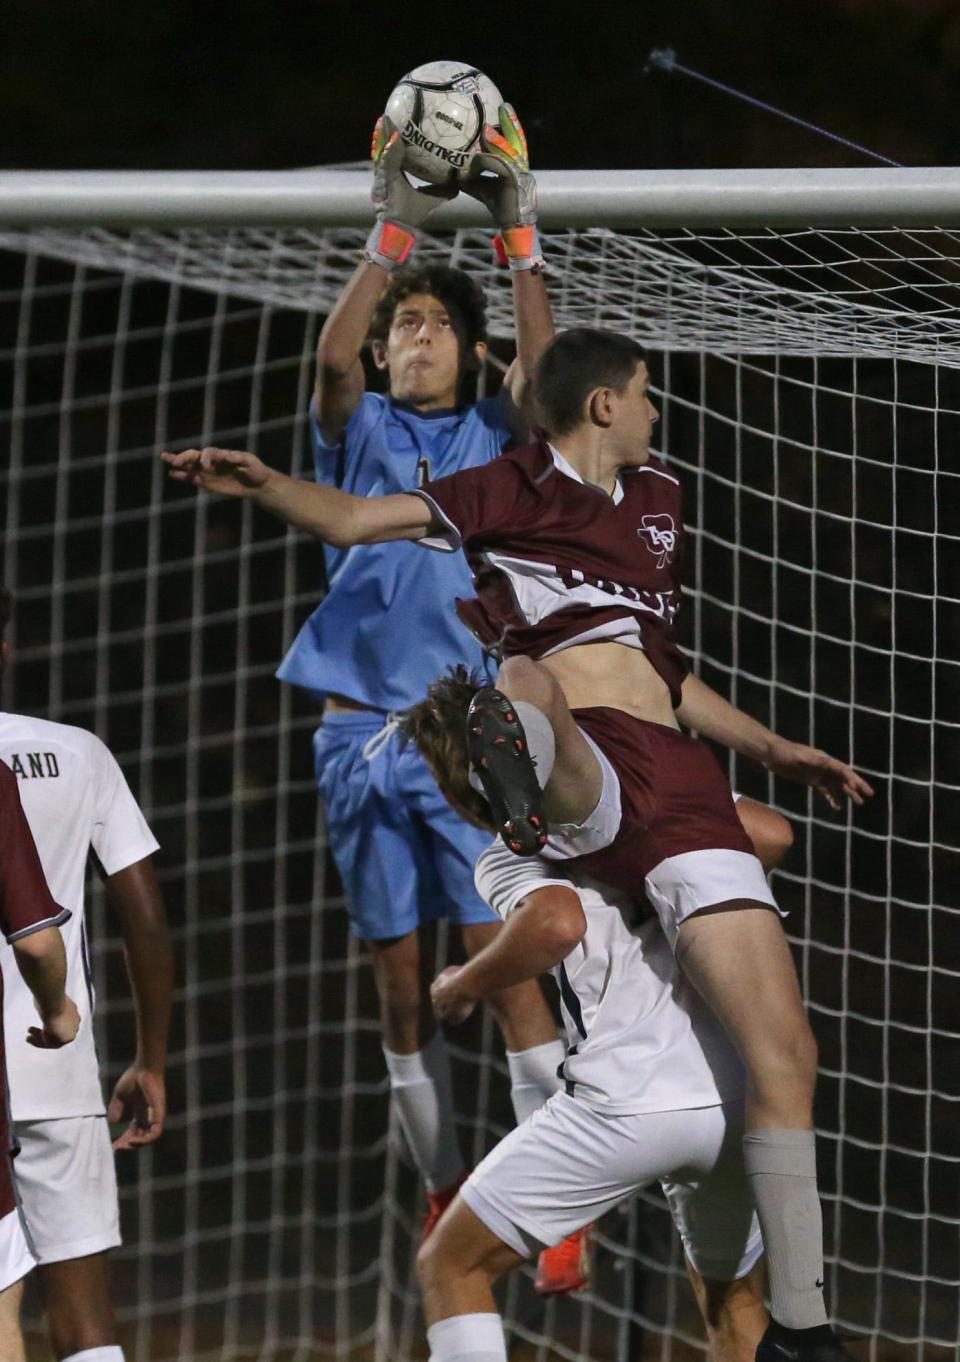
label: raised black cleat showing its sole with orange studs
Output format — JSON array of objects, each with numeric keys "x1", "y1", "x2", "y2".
[{"x1": 467, "y1": 685, "x2": 546, "y2": 855}]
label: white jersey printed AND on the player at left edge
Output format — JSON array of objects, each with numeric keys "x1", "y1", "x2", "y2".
[{"x1": 0, "y1": 714, "x2": 158, "y2": 1121}]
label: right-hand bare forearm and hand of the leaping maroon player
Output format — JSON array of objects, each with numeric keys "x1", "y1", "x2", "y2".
[{"x1": 677, "y1": 674, "x2": 873, "y2": 809}]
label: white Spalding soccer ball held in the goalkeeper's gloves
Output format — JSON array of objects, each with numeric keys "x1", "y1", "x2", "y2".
[{"x1": 385, "y1": 61, "x2": 504, "y2": 184}]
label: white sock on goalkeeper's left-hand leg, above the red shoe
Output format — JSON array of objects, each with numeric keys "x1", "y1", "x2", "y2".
[{"x1": 384, "y1": 1031, "x2": 466, "y2": 1192}]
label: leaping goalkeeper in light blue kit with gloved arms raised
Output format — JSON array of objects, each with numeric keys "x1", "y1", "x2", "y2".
[{"x1": 269, "y1": 106, "x2": 564, "y2": 1268}]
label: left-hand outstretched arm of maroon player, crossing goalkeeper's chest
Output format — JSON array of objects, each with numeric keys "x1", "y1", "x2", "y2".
[{"x1": 161, "y1": 447, "x2": 433, "y2": 549}]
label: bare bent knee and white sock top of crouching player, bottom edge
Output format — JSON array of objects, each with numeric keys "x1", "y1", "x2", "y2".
[{"x1": 417, "y1": 1197, "x2": 523, "y2": 1362}]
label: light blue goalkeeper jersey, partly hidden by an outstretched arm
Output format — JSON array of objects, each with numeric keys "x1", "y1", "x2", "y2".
[{"x1": 276, "y1": 392, "x2": 511, "y2": 711}]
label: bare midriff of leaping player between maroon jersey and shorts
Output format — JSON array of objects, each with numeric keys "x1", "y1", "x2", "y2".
[{"x1": 541, "y1": 643, "x2": 679, "y2": 729}]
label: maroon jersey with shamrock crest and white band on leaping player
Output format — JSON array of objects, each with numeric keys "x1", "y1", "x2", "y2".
[{"x1": 417, "y1": 443, "x2": 688, "y2": 704}]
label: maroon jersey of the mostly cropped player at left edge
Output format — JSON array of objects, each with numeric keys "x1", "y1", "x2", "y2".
[{"x1": 0, "y1": 761, "x2": 69, "y2": 1218}]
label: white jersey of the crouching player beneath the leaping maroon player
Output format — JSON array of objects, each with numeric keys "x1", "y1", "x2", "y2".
[{"x1": 475, "y1": 842, "x2": 745, "y2": 1115}]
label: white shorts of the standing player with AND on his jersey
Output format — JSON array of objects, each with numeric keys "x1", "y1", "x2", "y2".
[{"x1": 14, "y1": 1115, "x2": 120, "y2": 1263}]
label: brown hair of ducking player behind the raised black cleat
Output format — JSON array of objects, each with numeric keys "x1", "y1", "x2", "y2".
[{"x1": 399, "y1": 662, "x2": 496, "y2": 832}]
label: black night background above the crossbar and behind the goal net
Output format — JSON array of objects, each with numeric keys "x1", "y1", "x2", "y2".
[{"x1": 0, "y1": 0, "x2": 960, "y2": 1359}]
